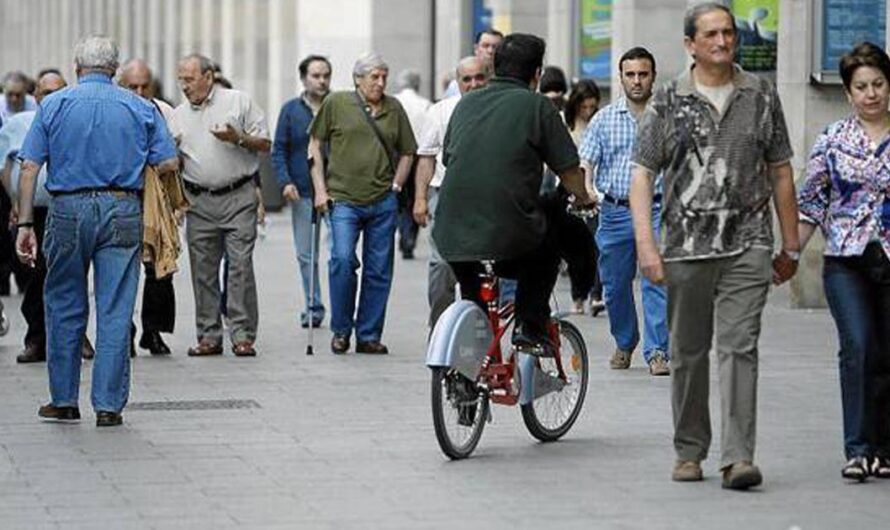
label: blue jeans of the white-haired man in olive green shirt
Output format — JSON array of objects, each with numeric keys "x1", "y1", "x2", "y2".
[{"x1": 328, "y1": 193, "x2": 398, "y2": 342}]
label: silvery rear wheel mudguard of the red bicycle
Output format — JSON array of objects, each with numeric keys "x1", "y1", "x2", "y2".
[{"x1": 426, "y1": 300, "x2": 494, "y2": 380}]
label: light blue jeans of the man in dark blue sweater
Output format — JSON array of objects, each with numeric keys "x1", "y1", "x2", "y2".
[{"x1": 291, "y1": 197, "x2": 325, "y2": 324}]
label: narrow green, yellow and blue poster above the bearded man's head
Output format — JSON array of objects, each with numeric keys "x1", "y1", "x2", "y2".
[{"x1": 578, "y1": 0, "x2": 612, "y2": 80}]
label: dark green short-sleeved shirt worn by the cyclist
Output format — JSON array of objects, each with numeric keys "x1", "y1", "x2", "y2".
[{"x1": 433, "y1": 78, "x2": 578, "y2": 261}]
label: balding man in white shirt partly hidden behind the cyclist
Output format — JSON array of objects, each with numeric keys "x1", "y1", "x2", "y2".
[{"x1": 413, "y1": 55, "x2": 491, "y2": 328}]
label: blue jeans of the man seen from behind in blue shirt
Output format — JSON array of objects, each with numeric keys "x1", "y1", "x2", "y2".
[{"x1": 43, "y1": 192, "x2": 142, "y2": 412}]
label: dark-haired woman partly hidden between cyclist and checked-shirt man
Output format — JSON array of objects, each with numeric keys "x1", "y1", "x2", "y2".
[{"x1": 563, "y1": 79, "x2": 606, "y2": 316}]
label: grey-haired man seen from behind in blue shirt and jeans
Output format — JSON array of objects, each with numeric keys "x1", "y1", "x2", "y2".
[{"x1": 16, "y1": 36, "x2": 178, "y2": 427}]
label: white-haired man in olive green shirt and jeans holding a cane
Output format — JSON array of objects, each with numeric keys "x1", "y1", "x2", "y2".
[{"x1": 309, "y1": 53, "x2": 417, "y2": 354}]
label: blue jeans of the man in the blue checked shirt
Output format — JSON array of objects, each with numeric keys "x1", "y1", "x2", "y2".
[{"x1": 596, "y1": 202, "x2": 668, "y2": 363}]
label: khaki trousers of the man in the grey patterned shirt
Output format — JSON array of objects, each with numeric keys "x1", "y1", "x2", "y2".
[{"x1": 665, "y1": 249, "x2": 772, "y2": 468}]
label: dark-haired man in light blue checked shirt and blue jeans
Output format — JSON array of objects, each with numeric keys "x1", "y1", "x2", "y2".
[{"x1": 580, "y1": 48, "x2": 670, "y2": 375}]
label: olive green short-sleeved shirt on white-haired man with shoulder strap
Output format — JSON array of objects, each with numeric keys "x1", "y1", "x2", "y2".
[{"x1": 310, "y1": 90, "x2": 417, "y2": 205}]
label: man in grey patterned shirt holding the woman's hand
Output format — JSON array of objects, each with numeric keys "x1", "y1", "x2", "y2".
[{"x1": 630, "y1": 2, "x2": 800, "y2": 489}]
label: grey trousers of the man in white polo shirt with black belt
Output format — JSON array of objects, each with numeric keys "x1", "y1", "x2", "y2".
[{"x1": 185, "y1": 183, "x2": 259, "y2": 344}]
